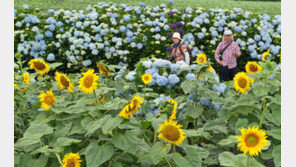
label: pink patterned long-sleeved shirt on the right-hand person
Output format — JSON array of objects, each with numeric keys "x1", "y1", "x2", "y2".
[{"x1": 215, "y1": 41, "x2": 241, "y2": 69}]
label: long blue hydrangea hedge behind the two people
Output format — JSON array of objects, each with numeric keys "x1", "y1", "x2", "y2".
[{"x1": 14, "y1": 2, "x2": 281, "y2": 72}]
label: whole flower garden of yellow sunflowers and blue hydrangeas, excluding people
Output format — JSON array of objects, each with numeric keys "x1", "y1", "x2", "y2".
[{"x1": 14, "y1": 0, "x2": 281, "y2": 167}]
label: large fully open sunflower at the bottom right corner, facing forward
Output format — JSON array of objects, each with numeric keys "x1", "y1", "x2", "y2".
[{"x1": 236, "y1": 126, "x2": 268, "y2": 156}]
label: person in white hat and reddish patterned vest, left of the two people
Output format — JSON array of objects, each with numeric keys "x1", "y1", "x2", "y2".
[{"x1": 169, "y1": 32, "x2": 192, "y2": 65}]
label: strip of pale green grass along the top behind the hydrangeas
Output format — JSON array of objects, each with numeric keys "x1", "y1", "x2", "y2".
[{"x1": 14, "y1": 0, "x2": 281, "y2": 16}]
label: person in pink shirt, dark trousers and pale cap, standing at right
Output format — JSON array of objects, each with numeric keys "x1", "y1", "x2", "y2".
[{"x1": 215, "y1": 30, "x2": 241, "y2": 81}]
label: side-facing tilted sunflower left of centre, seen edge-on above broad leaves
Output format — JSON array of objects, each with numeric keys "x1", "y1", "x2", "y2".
[{"x1": 118, "y1": 95, "x2": 144, "y2": 119}]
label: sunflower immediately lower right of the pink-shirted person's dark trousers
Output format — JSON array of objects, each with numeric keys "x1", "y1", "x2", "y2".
[{"x1": 234, "y1": 72, "x2": 254, "y2": 93}]
